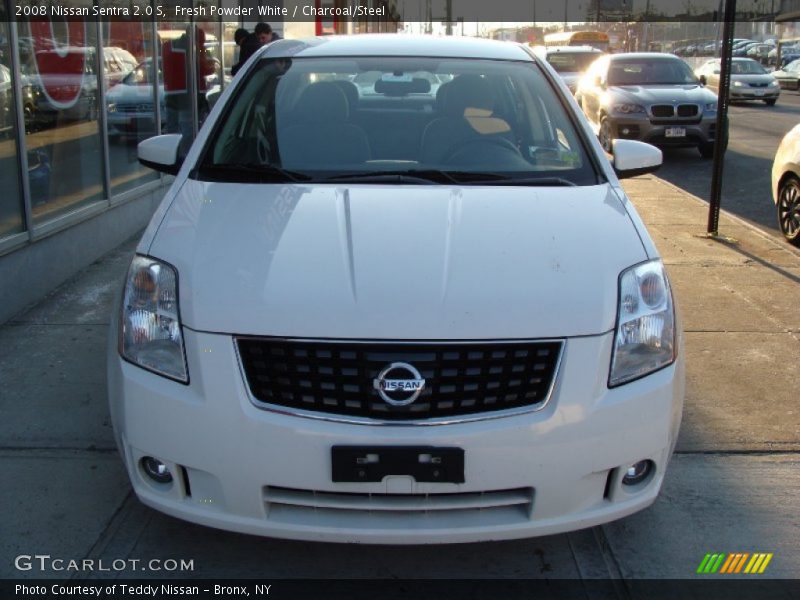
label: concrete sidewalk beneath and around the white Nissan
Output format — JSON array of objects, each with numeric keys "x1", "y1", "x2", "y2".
[{"x1": 0, "y1": 177, "x2": 800, "y2": 584}]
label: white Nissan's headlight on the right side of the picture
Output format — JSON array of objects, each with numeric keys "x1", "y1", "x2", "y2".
[{"x1": 608, "y1": 260, "x2": 677, "y2": 387}]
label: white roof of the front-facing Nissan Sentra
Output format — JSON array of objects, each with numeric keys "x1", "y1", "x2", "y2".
[{"x1": 260, "y1": 34, "x2": 536, "y2": 61}]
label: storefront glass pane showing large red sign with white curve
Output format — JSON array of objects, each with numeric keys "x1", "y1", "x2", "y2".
[{"x1": 18, "y1": 19, "x2": 104, "y2": 224}]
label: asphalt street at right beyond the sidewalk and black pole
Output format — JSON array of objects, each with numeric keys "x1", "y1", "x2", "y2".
[{"x1": 658, "y1": 90, "x2": 800, "y2": 240}]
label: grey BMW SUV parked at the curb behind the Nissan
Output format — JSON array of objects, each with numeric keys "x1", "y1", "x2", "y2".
[{"x1": 576, "y1": 52, "x2": 717, "y2": 158}]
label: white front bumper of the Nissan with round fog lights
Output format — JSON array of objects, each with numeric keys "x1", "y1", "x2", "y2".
[{"x1": 108, "y1": 329, "x2": 684, "y2": 544}]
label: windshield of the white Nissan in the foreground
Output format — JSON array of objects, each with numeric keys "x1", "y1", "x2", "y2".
[{"x1": 197, "y1": 57, "x2": 598, "y2": 185}]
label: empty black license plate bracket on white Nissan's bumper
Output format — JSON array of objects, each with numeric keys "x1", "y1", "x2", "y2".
[{"x1": 331, "y1": 446, "x2": 464, "y2": 483}]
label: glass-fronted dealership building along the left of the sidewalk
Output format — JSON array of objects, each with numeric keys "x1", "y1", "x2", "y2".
[{"x1": 0, "y1": 0, "x2": 399, "y2": 323}]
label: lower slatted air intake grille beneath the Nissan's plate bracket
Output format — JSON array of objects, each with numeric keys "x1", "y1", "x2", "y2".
[{"x1": 264, "y1": 486, "x2": 534, "y2": 529}]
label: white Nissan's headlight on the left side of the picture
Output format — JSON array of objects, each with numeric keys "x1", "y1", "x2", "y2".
[{"x1": 119, "y1": 256, "x2": 189, "y2": 383}]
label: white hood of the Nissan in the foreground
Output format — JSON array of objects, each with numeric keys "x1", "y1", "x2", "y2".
[{"x1": 148, "y1": 180, "x2": 647, "y2": 339}]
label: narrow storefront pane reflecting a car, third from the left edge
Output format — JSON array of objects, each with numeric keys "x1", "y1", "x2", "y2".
[{"x1": 103, "y1": 16, "x2": 159, "y2": 195}]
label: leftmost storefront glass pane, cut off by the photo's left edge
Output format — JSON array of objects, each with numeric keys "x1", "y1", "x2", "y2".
[{"x1": 0, "y1": 10, "x2": 24, "y2": 240}]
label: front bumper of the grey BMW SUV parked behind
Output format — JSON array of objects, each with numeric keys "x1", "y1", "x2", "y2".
[{"x1": 607, "y1": 113, "x2": 716, "y2": 146}]
